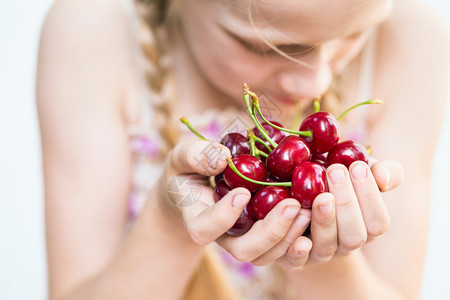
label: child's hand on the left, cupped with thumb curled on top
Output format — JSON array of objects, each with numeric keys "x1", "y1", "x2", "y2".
[{"x1": 157, "y1": 141, "x2": 310, "y2": 264}]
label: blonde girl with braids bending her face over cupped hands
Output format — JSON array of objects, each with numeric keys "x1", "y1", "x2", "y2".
[{"x1": 37, "y1": 0, "x2": 449, "y2": 299}]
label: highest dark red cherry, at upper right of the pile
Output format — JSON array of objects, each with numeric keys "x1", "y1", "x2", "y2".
[{"x1": 299, "y1": 111, "x2": 341, "y2": 153}]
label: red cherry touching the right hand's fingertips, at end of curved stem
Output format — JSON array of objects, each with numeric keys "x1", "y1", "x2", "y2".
[{"x1": 291, "y1": 161, "x2": 328, "y2": 208}]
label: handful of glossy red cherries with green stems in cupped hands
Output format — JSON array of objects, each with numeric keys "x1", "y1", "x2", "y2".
[{"x1": 181, "y1": 84, "x2": 383, "y2": 236}]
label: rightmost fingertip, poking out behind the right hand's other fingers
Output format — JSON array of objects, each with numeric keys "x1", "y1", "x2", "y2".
[{"x1": 371, "y1": 160, "x2": 403, "y2": 192}]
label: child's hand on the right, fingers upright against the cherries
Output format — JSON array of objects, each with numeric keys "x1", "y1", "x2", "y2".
[{"x1": 279, "y1": 161, "x2": 403, "y2": 269}]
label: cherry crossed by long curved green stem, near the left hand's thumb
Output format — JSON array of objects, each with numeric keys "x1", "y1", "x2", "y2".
[{"x1": 223, "y1": 154, "x2": 267, "y2": 192}]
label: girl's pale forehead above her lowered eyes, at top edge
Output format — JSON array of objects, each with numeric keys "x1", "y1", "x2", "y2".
[{"x1": 212, "y1": 0, "x2": 392, "y2": 43}]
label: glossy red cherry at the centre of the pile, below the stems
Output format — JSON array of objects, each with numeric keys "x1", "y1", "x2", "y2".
[{"x1": 266, "y1": 135, "x2": 311, "y2": 181}]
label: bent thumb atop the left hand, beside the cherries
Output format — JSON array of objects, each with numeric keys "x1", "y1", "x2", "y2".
[{"x1": 166, "y1": 140, "x2": 231, "y2": 176}]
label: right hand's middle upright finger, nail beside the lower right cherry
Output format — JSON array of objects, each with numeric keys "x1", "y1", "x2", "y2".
[{"x1": 326, "y1": 164, "x2": 367, "y2": 254}]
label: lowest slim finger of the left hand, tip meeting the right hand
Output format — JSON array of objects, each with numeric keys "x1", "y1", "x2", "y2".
[{"x1": 252, "y1": 208, "x2": 311, "y2": 266}]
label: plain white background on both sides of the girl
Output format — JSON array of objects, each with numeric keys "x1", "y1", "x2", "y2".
[{"x1": 0, "y1": 0, "x2": 450, "y2": 300}]
